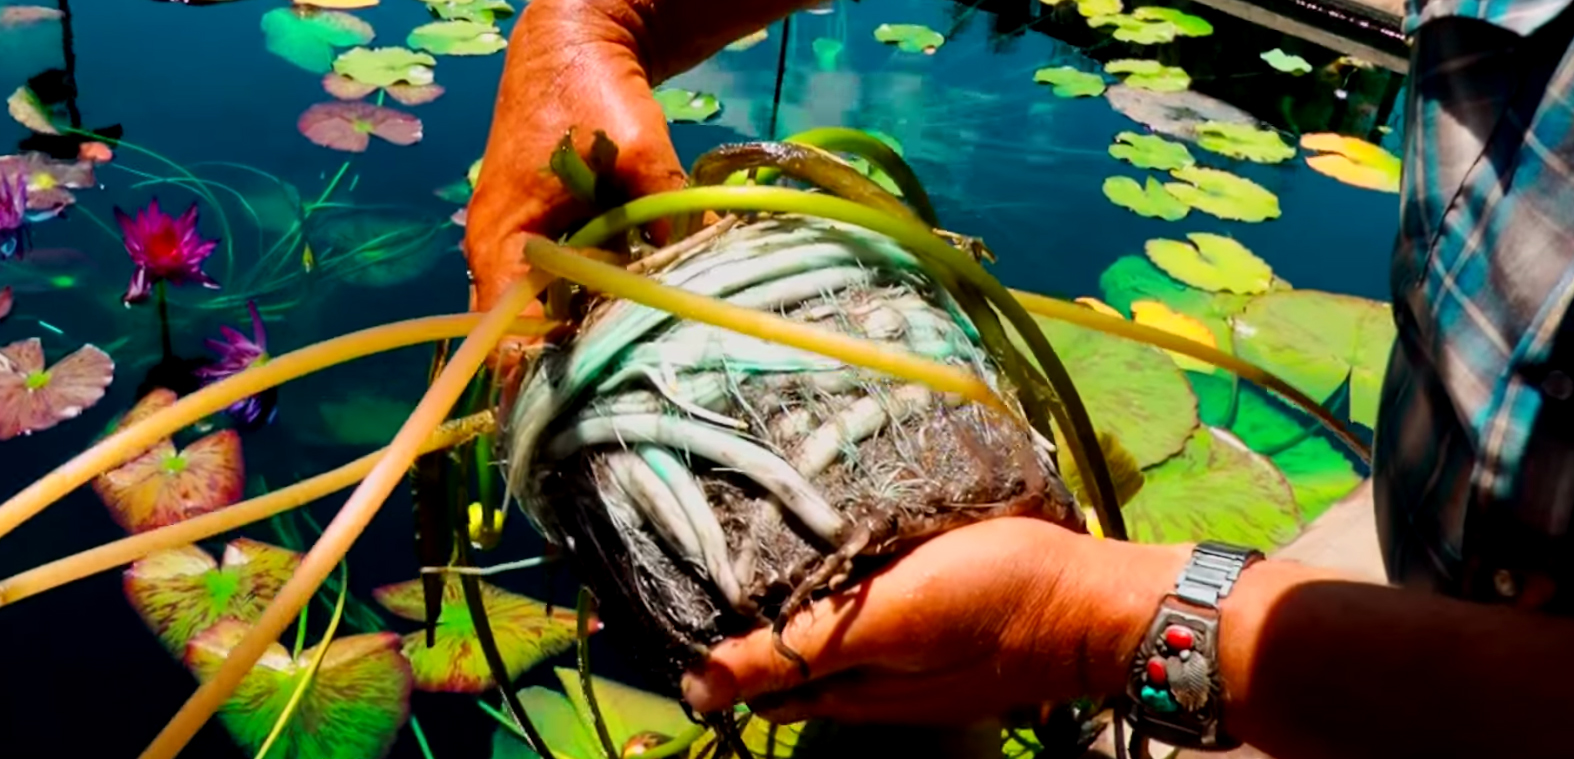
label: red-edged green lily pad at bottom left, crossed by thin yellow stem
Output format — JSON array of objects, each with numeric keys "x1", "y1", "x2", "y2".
[{"x1": 186, "y1": 619, "x2": 411, "y2": 759}]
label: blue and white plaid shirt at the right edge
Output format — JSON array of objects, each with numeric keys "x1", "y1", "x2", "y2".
[{"x1": 1374, "y1": 0, "x2": 1574, "y2": 605}]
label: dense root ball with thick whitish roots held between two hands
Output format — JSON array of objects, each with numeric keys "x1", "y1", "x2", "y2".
[{"x1": 507, "y1": 217, "x2": 1081, "y2": 680}]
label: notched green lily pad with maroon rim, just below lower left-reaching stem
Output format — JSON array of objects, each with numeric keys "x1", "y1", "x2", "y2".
[{"x1": 124, "y1": 537, "x2": 301, "y2": 657}]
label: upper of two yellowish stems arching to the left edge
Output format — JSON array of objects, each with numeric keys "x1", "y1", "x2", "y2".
[{"x1": 0, "y1": 312, "x2": 551, "y2": 537}]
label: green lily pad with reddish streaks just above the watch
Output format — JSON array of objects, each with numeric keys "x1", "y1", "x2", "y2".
[{"x1": 1122, "y1": 427, "x2": 1305, "y2": 551}]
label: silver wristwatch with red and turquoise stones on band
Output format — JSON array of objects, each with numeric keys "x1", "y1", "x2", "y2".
[{"x1": 1125, "y1": 542, "x2": 1262, "y2": 756}]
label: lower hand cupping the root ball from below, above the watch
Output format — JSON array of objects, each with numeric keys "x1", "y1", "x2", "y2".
[{"x1": 683, "y1": 518, "x2": 1187, "y2": 724}]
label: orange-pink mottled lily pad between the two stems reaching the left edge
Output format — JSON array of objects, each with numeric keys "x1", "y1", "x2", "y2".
[{"x1": 93, "y1": 389, "x2": 246, "y2": 532}]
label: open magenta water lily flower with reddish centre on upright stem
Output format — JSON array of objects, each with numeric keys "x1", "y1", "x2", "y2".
[{"x1": 115, "y1": 198, "x2": 219, "y2": 305}]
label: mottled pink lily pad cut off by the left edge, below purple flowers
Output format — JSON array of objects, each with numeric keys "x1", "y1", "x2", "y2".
[{"x1": 0, "y1": 337, "x2": 115, "y2": 439}]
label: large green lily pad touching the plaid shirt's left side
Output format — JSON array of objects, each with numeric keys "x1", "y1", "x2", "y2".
[{"x1": 1236, "y1": 290, "x2": 1395, "y2": 427}]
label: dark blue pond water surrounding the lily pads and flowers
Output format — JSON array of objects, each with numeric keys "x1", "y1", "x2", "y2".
[{"x1": 0, "y1": 0, "x2": 1402, "y2": 759}]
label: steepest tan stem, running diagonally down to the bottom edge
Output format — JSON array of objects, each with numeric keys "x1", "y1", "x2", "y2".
[{"x1": 142, "y1": 274, "x2": 548, "y2": 759}]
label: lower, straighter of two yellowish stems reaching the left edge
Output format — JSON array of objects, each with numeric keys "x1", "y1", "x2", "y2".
[{"x1": 0, "y1": 411, "x2": 497, "y2": 606}]
